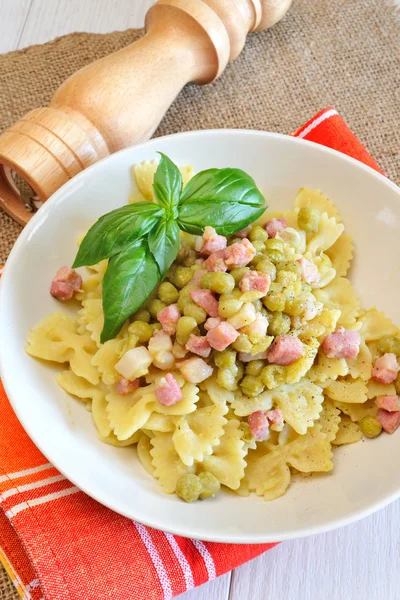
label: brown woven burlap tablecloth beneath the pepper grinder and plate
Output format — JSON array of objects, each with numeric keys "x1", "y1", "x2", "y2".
[{"x1": 0, "y1": 0, "x2": 400, "y2": 600}]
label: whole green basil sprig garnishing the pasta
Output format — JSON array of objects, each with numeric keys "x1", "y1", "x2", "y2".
[{"x1": 73, "y1": 153, "x2": 267, "y2": 343}]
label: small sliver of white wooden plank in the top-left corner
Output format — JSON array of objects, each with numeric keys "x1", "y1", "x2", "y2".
[{"x1": 0, "y1": 0, "x2": 32, "y2": 53}]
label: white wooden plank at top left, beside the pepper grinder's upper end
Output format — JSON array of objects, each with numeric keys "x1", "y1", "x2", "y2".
[{"x1": 18, "y1": 0, "x2": 154, "y2": 48}]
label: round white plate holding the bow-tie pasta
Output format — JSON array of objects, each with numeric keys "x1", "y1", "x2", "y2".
[{"x1": 0, "y1": 130, "x2": 400, "y2": 543}]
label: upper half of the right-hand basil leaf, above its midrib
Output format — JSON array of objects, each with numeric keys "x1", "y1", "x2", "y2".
[{"x1": 179, "y1": 169, "x2": 264, "y2": 206}]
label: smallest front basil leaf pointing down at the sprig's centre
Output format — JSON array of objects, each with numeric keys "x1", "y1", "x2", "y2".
[{"x1": 148, "y1": 219, "x2": 181, "y2": 276}]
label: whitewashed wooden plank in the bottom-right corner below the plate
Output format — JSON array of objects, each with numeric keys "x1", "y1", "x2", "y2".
[{"x1": 230, "y1": 502, "x2": 400, "y2": 600}]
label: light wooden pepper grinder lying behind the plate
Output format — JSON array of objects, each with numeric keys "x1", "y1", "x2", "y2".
[{"x1": 0, "y1": 0, "x2": 292, "y2": 225}]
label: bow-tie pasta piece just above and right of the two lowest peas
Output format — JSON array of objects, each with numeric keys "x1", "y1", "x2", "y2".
[{"x1": 201, "y1": 419, "x2": 246, "y2": 490}]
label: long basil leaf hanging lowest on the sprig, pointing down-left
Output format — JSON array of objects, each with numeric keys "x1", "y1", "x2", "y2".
[{"x1": 100, "y1": 239, "x2": 160, "y2": 343}]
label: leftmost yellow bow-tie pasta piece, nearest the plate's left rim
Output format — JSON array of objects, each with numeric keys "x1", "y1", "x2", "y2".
[{"x1": 26, "y1": 313, "x2": 100, "y2": 385}]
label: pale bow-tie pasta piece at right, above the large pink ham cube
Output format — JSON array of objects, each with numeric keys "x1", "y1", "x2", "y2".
[{"x1": 314, "y1": 277, "x2": 360, "y2": 329}]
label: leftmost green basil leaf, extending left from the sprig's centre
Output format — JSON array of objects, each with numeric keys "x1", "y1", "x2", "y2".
[{"x1": 72, "y1": 202, "x2": 165, "y2": 268}]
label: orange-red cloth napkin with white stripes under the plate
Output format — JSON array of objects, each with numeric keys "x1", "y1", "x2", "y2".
[{"x1": 0, "y1": 107, "x2": 382, "y2": 600}]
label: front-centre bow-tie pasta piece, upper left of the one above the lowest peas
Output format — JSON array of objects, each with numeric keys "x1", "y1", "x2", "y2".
[{"x1": 172, "y1": 404, "x2": 228, "y2": 467}]
